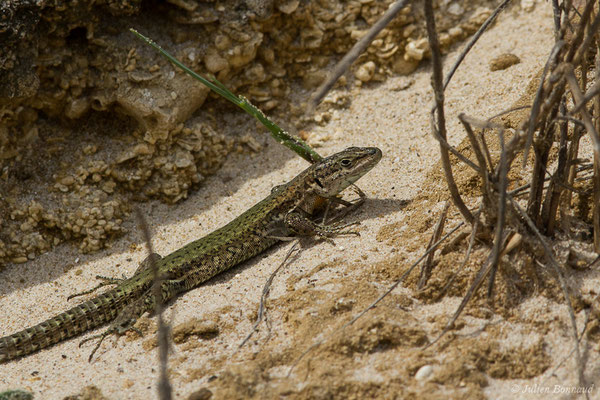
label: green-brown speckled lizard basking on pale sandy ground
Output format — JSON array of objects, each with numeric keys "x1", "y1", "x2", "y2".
[{"x1": 0, "y1": 147, "x2": 382, "y2": 363}]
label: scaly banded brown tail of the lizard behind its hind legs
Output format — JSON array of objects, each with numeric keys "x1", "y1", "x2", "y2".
[{"x1": 0, "y1": 288, "x2": 127, "y2": 363}]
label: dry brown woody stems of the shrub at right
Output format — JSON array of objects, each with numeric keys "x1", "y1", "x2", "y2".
[{"x1": 419, "y1": 1, "x2": 600, "y2": 397}]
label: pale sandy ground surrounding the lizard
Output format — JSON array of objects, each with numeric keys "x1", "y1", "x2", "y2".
[{"x1": 0, "y1": 2, "x2": 600, "y2": 399}]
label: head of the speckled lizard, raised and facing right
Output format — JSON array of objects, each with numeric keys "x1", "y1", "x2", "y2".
[{"x1": 313, "y1": 147, "x2": 381, "y2": 197}]
